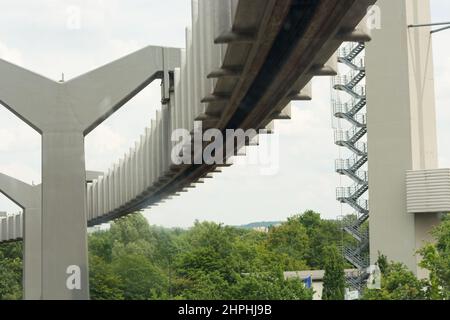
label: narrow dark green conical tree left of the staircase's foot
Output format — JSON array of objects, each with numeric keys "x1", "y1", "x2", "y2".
[{"x1": 322, "y1": 246, "x2": 345, "y2": 300}]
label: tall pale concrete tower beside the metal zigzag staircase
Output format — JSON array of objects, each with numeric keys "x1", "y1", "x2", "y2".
[{"x1": 366, "y1": 0, "x2": 439, "y2": 277}]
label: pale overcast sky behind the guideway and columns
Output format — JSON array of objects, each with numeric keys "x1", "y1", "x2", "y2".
[{"x1": 0, "y1": 0, "x2": 450, "y2": 227}]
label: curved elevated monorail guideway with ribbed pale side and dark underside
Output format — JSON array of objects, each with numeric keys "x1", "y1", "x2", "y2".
[{"x1": 88, "y1": 1, "x2": 374, "y2": 225}]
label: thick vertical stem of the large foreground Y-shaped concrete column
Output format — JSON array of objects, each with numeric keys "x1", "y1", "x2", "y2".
[{"x1": 42, "y1": 130, "x2": 89, "y2": 300}]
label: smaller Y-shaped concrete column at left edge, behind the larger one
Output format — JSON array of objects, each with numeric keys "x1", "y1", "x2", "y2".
[{"x1": 0, "y1": 173, "x2": 41, "y2": 300}]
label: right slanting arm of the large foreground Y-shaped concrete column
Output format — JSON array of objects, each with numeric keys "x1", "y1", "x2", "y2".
[{"x1": 64, "y1": 46, "x2": 180, "y2": 135}]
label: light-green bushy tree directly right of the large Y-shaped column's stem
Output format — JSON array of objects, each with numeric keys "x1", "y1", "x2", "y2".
[{"x1": 89, "y1": 214, "x2": 168, "y2": 300}]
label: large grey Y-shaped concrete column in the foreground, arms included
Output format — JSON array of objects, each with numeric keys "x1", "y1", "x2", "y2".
[{"x1": 0, "y1": 46, "x2": 180, "y2": 299}]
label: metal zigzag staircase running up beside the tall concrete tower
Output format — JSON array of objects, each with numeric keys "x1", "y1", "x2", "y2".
[{"x1": 332, "y1": 42, "x2": 369, "y2": 291}]
